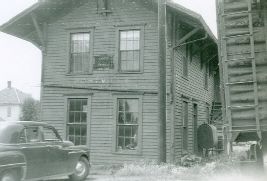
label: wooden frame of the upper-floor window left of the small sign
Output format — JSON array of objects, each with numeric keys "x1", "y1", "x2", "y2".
[{"x1": 67, "y1": 28, "x2": 94, "y2": 75}]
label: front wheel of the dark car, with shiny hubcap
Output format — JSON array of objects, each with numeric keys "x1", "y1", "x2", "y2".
[{"x1": 69, "y1": 157, "x2": 89, "y2": 181}]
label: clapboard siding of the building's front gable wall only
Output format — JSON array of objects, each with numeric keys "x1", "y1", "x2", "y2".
[{"x1": 41, "y1": 0, "x2": 162, "y2": 164}]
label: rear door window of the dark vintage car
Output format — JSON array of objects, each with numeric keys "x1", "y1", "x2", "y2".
[{"x1": 20, "y1": 126, "x2": 42, "y2": 143}]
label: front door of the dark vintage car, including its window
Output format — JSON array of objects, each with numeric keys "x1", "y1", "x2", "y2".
[{"x1": 42, "y1": 126, "x2": 68, "y2": 175}]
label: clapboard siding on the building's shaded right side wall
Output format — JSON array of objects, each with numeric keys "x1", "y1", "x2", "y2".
[{"x1": 174, "y1": 42, "x2": 214, "y2": 162}]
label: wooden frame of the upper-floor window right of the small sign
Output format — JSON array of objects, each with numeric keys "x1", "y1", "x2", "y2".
[{"x1": 114, "y1": 25, "x2": 145, "y2": 74}]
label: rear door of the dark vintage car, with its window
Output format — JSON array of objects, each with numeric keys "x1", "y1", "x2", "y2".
[{"x1": 20, "y1": 126, "x2": 47, "y2": 179}]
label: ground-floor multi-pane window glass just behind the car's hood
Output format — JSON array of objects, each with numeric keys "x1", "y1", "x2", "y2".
[{"x1": 67, "y1": 99, "x2": 87, "y2": 145}]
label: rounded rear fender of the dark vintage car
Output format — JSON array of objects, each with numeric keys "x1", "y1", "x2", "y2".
[{"x1": 0, "y1": 151, "x2": 27, "y2": 179}]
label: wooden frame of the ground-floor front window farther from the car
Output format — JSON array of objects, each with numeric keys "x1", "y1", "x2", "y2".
[{"x1": 112, "y1": 94, "x2": 143, "y2": 155}]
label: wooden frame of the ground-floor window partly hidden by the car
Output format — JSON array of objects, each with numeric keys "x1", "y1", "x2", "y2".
[{"x1": 62, "y1": 94, "x2": 92, "y2": 147}]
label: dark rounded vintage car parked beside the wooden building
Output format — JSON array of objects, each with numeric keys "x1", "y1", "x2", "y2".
[{"x1": 0, "y1": 121, "x2": 90, "y2": 181}]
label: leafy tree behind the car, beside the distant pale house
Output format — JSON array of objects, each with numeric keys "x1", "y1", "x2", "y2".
[{"x1": 20, "y1": 97, "x2": 40, "y2": 121}]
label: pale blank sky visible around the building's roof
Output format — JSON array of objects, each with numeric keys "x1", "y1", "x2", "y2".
[{"x1": 0, "y1": 0, "x2": 217, "y2": 99}]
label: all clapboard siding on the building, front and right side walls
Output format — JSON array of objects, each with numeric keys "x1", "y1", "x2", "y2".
[{"x1": 41, "y1": 0, "x2": 220, "y2": 164}]
